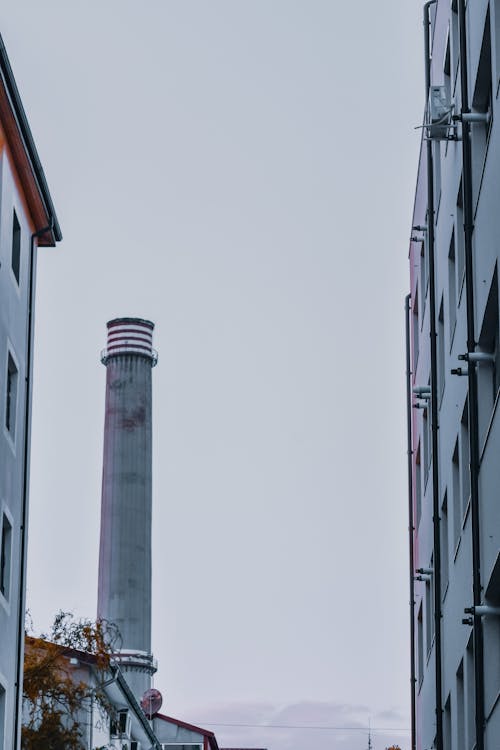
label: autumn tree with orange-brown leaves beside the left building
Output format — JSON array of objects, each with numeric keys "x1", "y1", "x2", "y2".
[{"x1": 21, "y1": 611, "x2": 119, "y2": 750}]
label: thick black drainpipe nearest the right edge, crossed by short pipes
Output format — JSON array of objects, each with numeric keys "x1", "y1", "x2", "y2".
[{"x1": 458, "y1": 0, "x2": 484, "y2": 750}]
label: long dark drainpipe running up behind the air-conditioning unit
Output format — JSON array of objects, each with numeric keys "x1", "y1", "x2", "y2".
[{"x1": 424, "y1": 0, "x2": 443, "y2": 750}]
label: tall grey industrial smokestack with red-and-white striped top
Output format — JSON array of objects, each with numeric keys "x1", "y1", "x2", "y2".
[{"x1": 97, "y1": 318, "x2": 157, "y2": 700}]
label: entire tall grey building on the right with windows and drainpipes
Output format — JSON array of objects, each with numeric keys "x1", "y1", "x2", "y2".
[{"x1": 407, "y1": 0, "x2": 500, "y2": 750}]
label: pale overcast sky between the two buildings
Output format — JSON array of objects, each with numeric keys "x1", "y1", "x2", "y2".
[{"x1": 0, "y1": 5, "x2": 423, "y2": 750}]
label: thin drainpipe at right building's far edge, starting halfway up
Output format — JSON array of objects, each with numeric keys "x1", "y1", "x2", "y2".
[{"x1": 405, "y1": 294, "x2": 416, "y2": 750}]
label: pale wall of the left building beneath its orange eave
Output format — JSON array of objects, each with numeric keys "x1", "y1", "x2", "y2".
[{"x1": 0, "y1": 147, "x2": 36, "y2": 748}]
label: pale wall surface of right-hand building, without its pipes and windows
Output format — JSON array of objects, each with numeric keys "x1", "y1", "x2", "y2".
[{"x1": 410, "y1": 0, "x2": 500, "y2": 750}]
